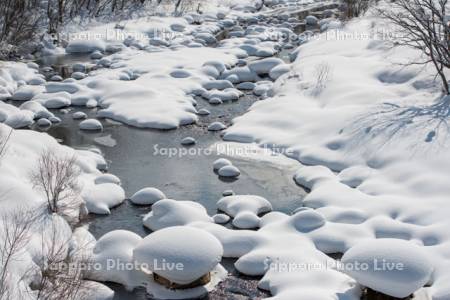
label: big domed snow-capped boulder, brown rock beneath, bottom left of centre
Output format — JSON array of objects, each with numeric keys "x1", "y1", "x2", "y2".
[{"x1": 133, "y1": 226, "x2": 223, "y2": 284}]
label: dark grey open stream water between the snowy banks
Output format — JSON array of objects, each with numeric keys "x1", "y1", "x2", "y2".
[{"x1": 25, "y1": 4, "x2": 342, "y2": 300}]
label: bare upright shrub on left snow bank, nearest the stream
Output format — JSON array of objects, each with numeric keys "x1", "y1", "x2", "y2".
[{"x1": 30, "y1": 149, "x2": 80, "y2": 214}]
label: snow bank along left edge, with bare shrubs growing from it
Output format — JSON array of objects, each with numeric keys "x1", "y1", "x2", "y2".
[{"x1": 0, "y1": 123, "x2": 118, "y2": 299}]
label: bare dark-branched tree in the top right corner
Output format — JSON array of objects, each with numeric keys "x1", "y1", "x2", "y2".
[{"x1": 378, "y1": 0, "x2": 450, "y2": 95}]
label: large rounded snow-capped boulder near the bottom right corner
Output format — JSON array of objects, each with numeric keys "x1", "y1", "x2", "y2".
[{"x1": 342, "y1": 239, "x2": 433, "y2": 298}]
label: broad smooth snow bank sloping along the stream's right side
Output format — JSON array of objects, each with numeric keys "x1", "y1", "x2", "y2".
[{"x1": 220, "y1": 8, "x2": 450, "y2": 299}]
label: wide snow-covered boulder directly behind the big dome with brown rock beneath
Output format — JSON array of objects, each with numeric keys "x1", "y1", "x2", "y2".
[{"x1": 143, "y1": 199, "x2": 212, "y2": 231}]
